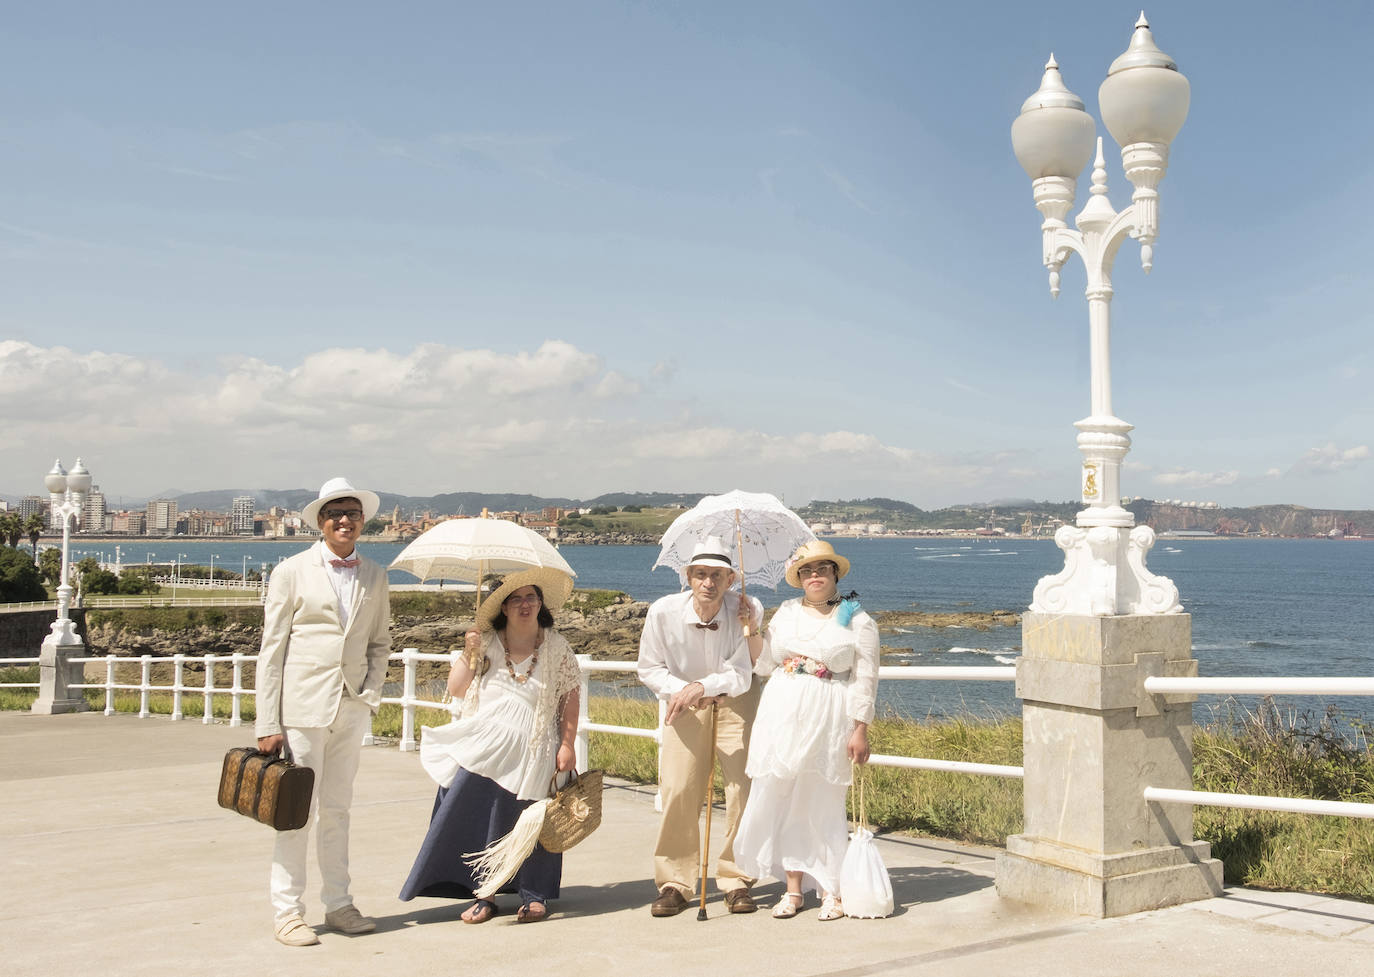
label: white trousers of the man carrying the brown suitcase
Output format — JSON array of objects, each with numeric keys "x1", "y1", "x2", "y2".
[{"x1": 272, "y1": 697, "x2": 372, "y2": 919}]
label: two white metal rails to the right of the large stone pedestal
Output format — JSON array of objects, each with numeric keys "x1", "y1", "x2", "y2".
[{"x1": 1143, "y1": 676, "x2": 1374, "y2": 818}]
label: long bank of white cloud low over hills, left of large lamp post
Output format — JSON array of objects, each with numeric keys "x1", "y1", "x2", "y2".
[{"x1": 0, "y1": 339, "x2": 1062, "y2": 506}]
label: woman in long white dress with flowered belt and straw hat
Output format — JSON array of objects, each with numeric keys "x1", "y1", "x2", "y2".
[{"x1": 735, "y1": 540, "x2": 878, "y2": 919}]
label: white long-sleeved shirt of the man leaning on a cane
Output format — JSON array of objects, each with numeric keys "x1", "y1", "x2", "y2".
[{"x1": 639, "y1": 591, "x2": 764, "y2": 701}]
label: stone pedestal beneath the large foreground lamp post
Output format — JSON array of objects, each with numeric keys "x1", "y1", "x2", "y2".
[{"x1": 998, "y1": 613, "x2": 1221, "y2": 917}]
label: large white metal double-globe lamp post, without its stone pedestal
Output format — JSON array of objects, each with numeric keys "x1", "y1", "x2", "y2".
[{"x1": 1011, "y1": 14, "x2": 1189, "y2": 614}]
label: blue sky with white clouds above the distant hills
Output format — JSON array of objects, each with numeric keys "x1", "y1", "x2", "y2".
[{"x1": 0, "y1": 0, "x2": 1374, "y2": 508}]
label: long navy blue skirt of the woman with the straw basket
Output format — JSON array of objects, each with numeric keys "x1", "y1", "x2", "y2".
[{"x1": 401, "y1": 767, "x2": 563, "y2": 903}]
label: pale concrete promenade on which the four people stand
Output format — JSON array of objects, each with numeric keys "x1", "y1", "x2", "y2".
[{"x1": 0, "y1": 713, "x2": 1374, "y2": 977}]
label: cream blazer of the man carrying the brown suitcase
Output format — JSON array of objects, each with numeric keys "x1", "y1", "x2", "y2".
[{"x1": 256, "y1": 543, "x2": 392, "y2": 737}]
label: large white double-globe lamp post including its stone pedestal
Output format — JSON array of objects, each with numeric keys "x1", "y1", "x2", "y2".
[{"x1": 998, "y1": 14, "x2": 1221, "y2": 917}]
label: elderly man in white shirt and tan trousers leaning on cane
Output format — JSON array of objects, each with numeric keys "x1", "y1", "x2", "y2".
[{"x1": 639, "y1": 536, "x2": 763, "y2": 918}]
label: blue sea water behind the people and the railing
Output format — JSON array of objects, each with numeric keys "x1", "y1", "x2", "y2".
[{"x1": 91, "y1": 537, "x2": 1374, "y2": 720}]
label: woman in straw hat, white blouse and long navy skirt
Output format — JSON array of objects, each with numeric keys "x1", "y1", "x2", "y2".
[{"x1": 401, "y1": 569, "x2": 581, "y2": 923}]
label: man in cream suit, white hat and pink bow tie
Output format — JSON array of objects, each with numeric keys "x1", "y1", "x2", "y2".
[{"x1": 257, "y1": 478, "x2": 392, "y2": 947}]
